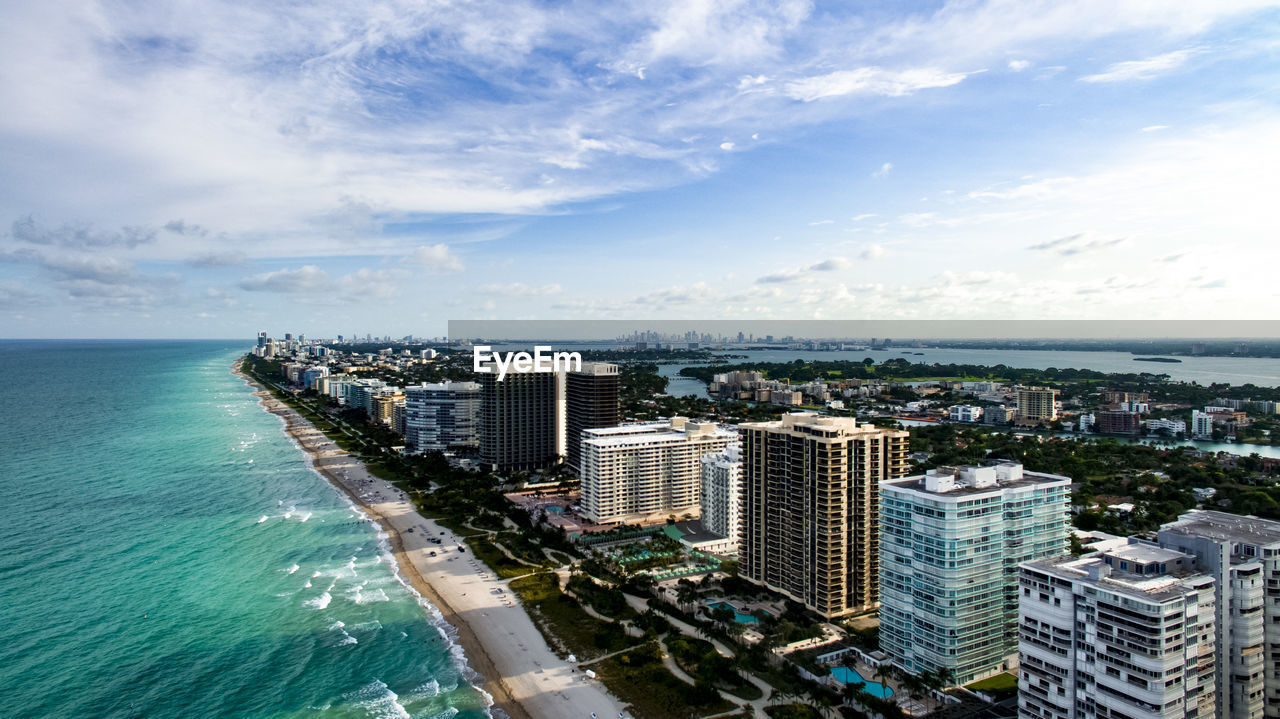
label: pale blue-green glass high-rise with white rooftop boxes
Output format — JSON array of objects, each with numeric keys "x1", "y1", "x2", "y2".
[{"x1": 879, "y1": 463, "x2": 1071, "y2": 684}]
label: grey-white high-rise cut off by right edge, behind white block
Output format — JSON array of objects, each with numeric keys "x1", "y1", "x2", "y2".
[{"x1": 1158, "y1": 509, "x2": 1280, "y2": 719}]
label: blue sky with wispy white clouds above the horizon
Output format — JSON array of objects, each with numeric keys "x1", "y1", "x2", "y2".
[{"x1": 0, "y1": 0, "x2": 1280, "y2": 338}]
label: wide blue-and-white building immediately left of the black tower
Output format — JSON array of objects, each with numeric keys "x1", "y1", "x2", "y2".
[{"x1": 404, "y1": 381, "x2": 480, "y2": 453}]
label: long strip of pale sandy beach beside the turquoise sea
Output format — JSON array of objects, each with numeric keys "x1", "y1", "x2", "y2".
[{"x1": 234, "y1": 363, "x2": 630, "y2": 719}]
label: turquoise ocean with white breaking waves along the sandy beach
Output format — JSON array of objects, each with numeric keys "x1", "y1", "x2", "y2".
[{"x1": 0, "y1": 340, "x2": 488, "y2": 719}]
